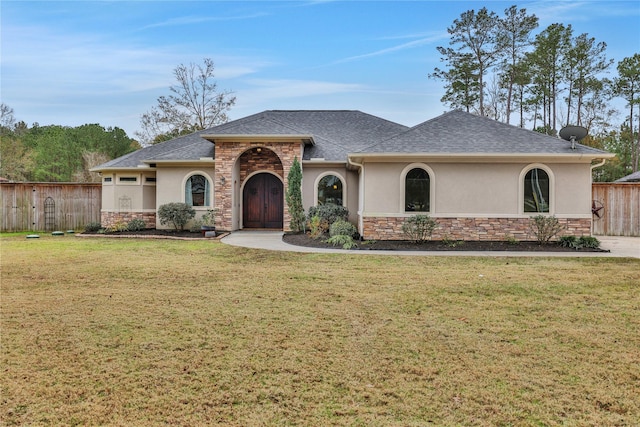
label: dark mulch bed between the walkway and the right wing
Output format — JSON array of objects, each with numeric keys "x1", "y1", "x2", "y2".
[{"x1": 283, "y1": 234, "x2": 609, "y2": 252}]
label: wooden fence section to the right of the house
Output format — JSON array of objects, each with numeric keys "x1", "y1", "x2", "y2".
[{"x1": 591, "y1": 182, "x2": 640, "y2": 236}]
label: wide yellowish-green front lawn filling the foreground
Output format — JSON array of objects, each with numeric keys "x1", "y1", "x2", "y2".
[{"x1": 0, "y1": 235, "x2": 640, "y2": 426}]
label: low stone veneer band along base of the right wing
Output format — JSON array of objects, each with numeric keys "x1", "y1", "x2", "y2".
[{"x1": 363, "y1": 217, "x2": 591, "y2": 241}]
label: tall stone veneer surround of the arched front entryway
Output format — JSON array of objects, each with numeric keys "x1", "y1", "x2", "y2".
[{"x1": 214, "y1": 141, "x2": 302, "y2": 231}]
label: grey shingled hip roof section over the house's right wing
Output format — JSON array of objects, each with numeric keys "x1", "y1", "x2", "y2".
[{"x1": 357, "y1": 110, "x2": 610, "y2": 157}]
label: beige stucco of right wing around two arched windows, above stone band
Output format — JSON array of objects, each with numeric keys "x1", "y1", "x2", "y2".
[{"x1": 363, "y1": 162, "x2": 591, "y2": 217}]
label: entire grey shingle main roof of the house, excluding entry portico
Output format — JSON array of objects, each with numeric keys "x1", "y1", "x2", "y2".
[{"x1": 93, "y1": 110, "x2": 608, "y2": 170}]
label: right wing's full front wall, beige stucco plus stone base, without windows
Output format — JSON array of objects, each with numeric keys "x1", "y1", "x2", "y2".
[{"x1": 360, "y1": 161, "x2": 591, "y2": 240}]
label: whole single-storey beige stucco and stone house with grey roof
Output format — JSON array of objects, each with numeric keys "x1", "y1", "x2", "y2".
[{"x1": 93, "y1": 111, "x2": 614, "y2": 240}]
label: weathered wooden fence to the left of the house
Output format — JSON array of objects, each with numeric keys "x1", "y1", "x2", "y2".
[{"x1": 0, "y1": 182, "x2": 102, "y2": 231}]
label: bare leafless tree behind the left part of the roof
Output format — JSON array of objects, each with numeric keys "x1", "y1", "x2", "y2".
[{"x1": 136, "y1": 58, "x2": 236, "y2": 145}]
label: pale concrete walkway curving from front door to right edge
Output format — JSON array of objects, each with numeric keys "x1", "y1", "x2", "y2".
[{"x1": 222, "y1": 231, "x2": 640, "y2": 258}]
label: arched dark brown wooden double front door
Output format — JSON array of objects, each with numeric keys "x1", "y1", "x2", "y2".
[{"x1": 242, "y1": 173, "x2": 284, "y2": 229}]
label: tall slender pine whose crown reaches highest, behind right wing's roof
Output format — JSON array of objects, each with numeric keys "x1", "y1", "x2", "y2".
[{"x1": 497, "y1": 5, "x2": 538, "y2": 123}]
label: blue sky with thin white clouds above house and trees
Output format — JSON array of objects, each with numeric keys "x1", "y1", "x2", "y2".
[{"x1": 0, "y1": 0, "x2": 640, "y2": 137}]
